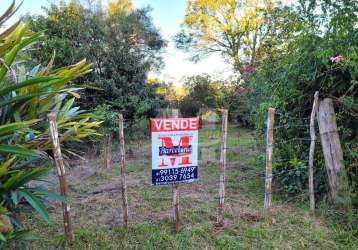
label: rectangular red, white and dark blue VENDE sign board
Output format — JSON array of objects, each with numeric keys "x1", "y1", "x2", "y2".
[{"x1": 151, "y1": 117, "x2": 199, "y2": 185}]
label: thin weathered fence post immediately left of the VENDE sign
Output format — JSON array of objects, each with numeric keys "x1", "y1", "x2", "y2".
[{"x1": 118, "y1": 114, "x2": 128, "y2": 227}]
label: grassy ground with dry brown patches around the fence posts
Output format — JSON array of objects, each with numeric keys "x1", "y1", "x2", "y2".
[{"x1": 26, "y1": 126, "x2": 358, "y2": 249}]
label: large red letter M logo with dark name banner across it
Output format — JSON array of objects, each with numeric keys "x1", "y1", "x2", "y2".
[{"x1": 159, "y1": 136, "x2": 191, "y2": 167}]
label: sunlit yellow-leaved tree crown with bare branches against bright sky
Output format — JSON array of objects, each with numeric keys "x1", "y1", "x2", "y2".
[{"x1": 175, "y1": 0, "x2": 274, "y2": 73}]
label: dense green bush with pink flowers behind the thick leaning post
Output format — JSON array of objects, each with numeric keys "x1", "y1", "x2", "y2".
[{"x1": 245, "y1": 0, "x2": 358, "y2": 202}]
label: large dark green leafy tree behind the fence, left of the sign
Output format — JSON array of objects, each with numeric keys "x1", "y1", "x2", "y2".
[{"x1": 28, "y1": 1, "x2": 165, "y2": 134}]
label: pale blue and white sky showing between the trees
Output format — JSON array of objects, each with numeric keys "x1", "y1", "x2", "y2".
[{"x1": 0, "y1": 0, "x2": 231, "y2": 86}]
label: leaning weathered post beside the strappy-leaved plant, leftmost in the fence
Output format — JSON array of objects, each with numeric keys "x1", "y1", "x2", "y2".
[{"x1": 47, "y1": 113, "x2": 74, "y2": 243}]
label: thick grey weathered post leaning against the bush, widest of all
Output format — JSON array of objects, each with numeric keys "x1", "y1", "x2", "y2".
[{"x1": 318, "y1": 98, "x2": 344, "y2": 200}]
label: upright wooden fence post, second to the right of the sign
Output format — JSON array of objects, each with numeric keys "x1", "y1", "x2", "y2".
[{"x1": 264, "y1": 108, "x2": 275, "y2": 212}]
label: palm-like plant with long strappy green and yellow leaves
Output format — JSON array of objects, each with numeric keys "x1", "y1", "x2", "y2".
[{"x1": 0, "y1": 0, "x2": 100, "y2": 247}]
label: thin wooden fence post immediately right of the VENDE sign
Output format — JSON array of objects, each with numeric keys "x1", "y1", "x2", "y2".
[{"x1": 216, "y1": 109, "x2": 228, "y2": 226}]
